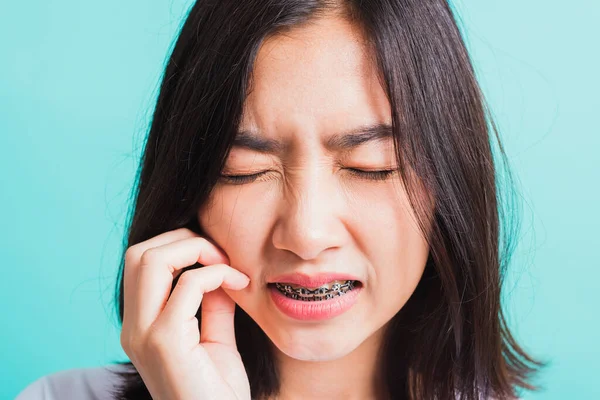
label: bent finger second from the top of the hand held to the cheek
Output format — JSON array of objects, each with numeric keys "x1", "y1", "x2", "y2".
[{"x1": 133, "y1": 237, "x2": 241, "y2": 331}]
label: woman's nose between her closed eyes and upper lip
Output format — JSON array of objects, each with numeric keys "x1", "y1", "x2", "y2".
[{"x1": 272, "y1": 168, "x2": 348, "y2": 260}]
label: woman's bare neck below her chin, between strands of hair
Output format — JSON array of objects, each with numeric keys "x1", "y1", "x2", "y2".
[{"x1": 269, "y1": 326, "x2": 387, "y2": 400}]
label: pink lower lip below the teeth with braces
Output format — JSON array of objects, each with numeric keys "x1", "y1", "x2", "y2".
[{"x1": 268, "y1": 286, "x2": 362, "y2": 321}]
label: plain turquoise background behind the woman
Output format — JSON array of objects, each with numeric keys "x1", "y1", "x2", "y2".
[{"x1": 0, "y1": 0, "x2": 600, "y2": 400}]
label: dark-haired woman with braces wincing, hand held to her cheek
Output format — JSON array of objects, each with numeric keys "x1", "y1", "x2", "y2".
[{"x1": 16, "y1": 0, "x2": 543, "y2": 400}]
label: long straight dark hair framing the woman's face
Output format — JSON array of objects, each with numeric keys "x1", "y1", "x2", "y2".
[{"x1": 106, "y1": 0, "x2": 546, "y2": 400}]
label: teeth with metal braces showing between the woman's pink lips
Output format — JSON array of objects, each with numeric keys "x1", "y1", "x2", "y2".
[{"x1": 267, "y1": 280, "x2": 362, "y2": 302}]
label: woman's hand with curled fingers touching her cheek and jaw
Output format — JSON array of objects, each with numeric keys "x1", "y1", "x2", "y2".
[{"x1": 121, "y1": 228, "x2": 250, "y2": 400}]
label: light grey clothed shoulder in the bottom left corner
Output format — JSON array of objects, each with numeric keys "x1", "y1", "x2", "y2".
[{"x1": 15, "y1": 364, "x2": 131, "y2": 400}]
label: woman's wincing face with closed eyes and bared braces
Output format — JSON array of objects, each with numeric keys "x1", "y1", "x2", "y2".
[{"x1": 198, "y1": 15, "x2": 429, "y2": 361}]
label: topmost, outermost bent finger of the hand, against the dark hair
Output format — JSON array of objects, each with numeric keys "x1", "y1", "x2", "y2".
[{"x1": 123, "y1": 228, "x2": 202, "y2": 322}]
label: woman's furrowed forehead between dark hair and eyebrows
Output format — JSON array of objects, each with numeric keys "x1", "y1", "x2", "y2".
[{"x1": 240, "y1": 17, "x2": 391, "y2": 147}]
